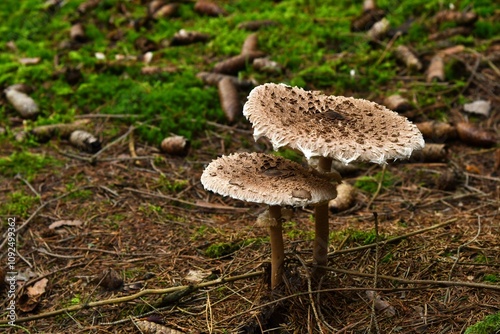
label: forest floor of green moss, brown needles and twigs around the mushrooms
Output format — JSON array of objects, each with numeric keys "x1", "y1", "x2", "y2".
[{"x1": 0, "y1": 0, "x2": 500, "y2": 334}]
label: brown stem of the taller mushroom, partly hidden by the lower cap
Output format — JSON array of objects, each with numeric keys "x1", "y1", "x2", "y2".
[{"x1": 313, "y1": 157, "x2": 332, "y2": 280}]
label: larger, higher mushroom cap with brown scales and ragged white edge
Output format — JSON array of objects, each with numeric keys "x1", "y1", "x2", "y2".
[{"x1": 243, "y1": 83, "x2": 425, "y2": 164}]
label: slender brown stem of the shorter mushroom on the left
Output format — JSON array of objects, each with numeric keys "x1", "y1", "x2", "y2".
[{"x1": 269, "y1": 205, "x2": 284, "y2": 289}]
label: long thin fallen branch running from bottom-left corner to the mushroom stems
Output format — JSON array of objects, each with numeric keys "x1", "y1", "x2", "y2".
[{"x1": 0, "y1": 271, "x2": 264, "y2": 325}]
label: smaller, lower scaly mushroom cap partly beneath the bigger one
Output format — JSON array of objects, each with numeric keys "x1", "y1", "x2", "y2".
[{"x1": 201, "y1": 153, "x2": 337, "y2": 206}]
